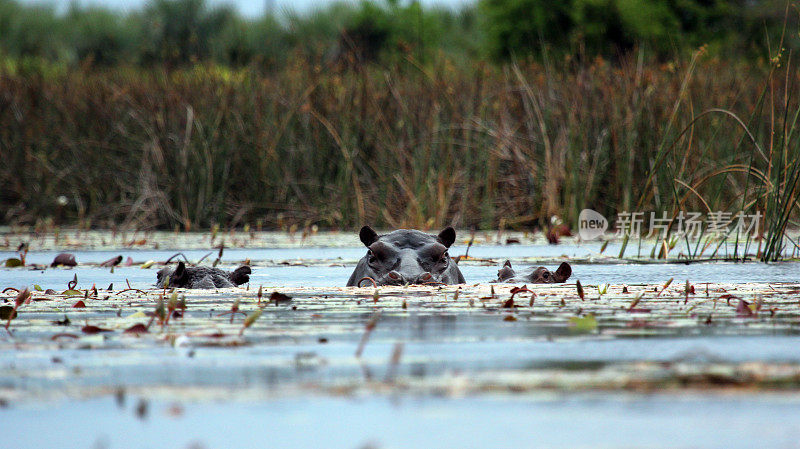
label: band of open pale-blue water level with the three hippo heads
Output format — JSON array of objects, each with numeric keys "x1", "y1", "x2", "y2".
[{"x1": 0, "y1": 245, "x2": 800, "y2": 289}]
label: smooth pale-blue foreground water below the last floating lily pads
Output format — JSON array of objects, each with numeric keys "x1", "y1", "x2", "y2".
[{"x1": 6, "y1": 394, "x2": 800, "y2": 449}]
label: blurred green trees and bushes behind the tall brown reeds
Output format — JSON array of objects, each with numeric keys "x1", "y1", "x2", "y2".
[{"x1": 0, "y1": 0, "x2": 797, "y2": 70}]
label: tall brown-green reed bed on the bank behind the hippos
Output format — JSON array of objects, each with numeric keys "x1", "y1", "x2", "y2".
[{"x1": 0, "y1": 53, "x2": 797, "y2": 234}]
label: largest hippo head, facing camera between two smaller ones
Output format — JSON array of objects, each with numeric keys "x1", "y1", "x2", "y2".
[{"x1": 347, "y1": 226, "x2": 465, "y2": 286}]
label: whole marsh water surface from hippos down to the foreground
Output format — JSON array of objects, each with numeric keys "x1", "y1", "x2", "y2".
[{"x1": 0, "y1": 236, "x2": 800, "y2": 448}]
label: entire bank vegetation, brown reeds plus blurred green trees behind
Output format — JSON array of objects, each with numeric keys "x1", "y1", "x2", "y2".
[{"x1": 0, "y1": 0, "x2": 800, "y2": 229}]
